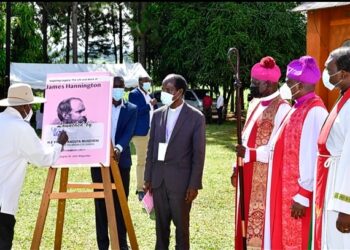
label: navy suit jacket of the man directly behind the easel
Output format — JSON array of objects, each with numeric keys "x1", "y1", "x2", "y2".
[{"x1": 114, "y1": 102, "x2": 137, "y2": 168}]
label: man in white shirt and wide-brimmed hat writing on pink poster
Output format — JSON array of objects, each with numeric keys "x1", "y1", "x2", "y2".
[{"x1": 0, "y1": 83, "x2": 68, "y2": 249}]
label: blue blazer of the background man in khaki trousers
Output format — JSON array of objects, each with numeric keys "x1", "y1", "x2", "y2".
[{"x1": 129, "y1": 88, "x2": 151, "y2": 136}]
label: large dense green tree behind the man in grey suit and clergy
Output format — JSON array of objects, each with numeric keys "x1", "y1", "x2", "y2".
[{"x1": 131, "y1": 2, "x2": 305, "y2": 110}]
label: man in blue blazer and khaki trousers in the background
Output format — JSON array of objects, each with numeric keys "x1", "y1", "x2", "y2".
[{"x1": 129, "y1": 76, "x2": 157, "y2": 201}]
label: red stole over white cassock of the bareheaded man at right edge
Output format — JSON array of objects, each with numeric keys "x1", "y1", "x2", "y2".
[{"x1": 314, "y1": 89, "x2": 350, "y2": 250}]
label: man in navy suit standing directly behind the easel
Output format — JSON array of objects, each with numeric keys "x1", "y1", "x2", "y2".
[{"x1": 91, "y1": 76, "x2": 137, "y2": 250}]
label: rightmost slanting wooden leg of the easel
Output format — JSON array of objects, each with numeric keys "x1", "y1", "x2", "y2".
[{"x1": 111, "y1": 158, "x2": 139, "y2": 250}]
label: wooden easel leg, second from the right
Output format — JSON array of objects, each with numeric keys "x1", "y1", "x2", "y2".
[{"x1": 101, "y1": 167, "x2": 119, "y2": 250}]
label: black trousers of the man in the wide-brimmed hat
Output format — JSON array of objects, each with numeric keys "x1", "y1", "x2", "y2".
[{"x1": 0, "y1": 212, "x2": 16, "y2": 250}]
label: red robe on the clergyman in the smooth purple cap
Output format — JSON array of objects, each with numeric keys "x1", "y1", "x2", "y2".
[{"x1": 270, "y1": 96, "x2": 325, "y2": 249}]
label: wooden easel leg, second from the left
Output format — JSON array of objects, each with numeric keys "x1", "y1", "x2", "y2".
[{"x1": 54, "y1": 168, "x2": 69, "y2": 250}]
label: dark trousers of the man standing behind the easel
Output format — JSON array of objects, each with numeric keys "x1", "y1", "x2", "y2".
[{"x1": 91, "y1": 168, "x2": 130, "y2": 250}]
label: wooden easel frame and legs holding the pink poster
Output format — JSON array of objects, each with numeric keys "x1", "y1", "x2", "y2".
[{"x1": 30, "y1": 146, "x2": 139, "y2": 250}]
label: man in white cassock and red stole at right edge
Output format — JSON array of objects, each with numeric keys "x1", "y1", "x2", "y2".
[{"x1": 313, "y1": 47, "x2": 350, "y2": 249}]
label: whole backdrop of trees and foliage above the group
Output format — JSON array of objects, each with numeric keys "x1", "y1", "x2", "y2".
[{"x1": 0, "y1": 2, "x2": 306, "y2": 103}]
